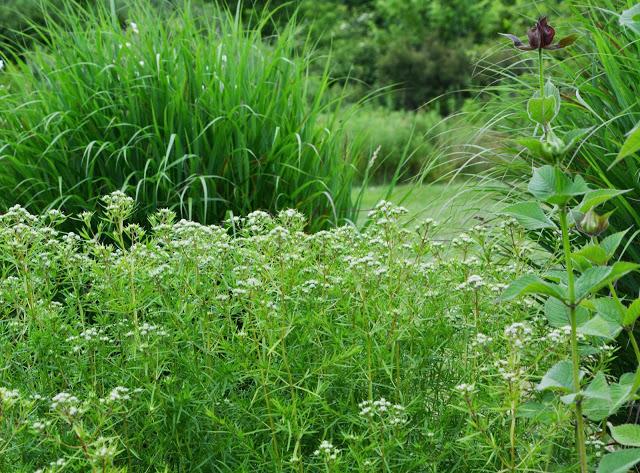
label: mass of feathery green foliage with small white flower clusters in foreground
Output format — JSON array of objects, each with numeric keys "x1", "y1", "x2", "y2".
[{"x1": 0, "y1": 193, "x2": 571, "y2": 473}]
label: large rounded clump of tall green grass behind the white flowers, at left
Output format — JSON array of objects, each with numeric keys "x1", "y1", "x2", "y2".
[{"x1": 0, "y1": 2, "x2": 354, "y2": 228}]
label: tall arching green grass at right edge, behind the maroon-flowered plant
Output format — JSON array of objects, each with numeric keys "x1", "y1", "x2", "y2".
[{"x1": 487, "y1": 0, "x2": 640, "y2": 270}]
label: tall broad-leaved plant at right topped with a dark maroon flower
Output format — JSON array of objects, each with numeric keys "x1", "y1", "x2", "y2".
[{"x1": 502, "y1": 14, "x2": 640, "y2": 473}]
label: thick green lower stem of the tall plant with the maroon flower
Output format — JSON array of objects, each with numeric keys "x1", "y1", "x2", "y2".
[{"x1": 560, "y1": 206, "x2": 589, "y2": 473}]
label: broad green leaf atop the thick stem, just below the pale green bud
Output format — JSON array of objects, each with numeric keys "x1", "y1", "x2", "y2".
[{"x1": 529, "y1": 165, "x2": 589, "y2": 204}]
